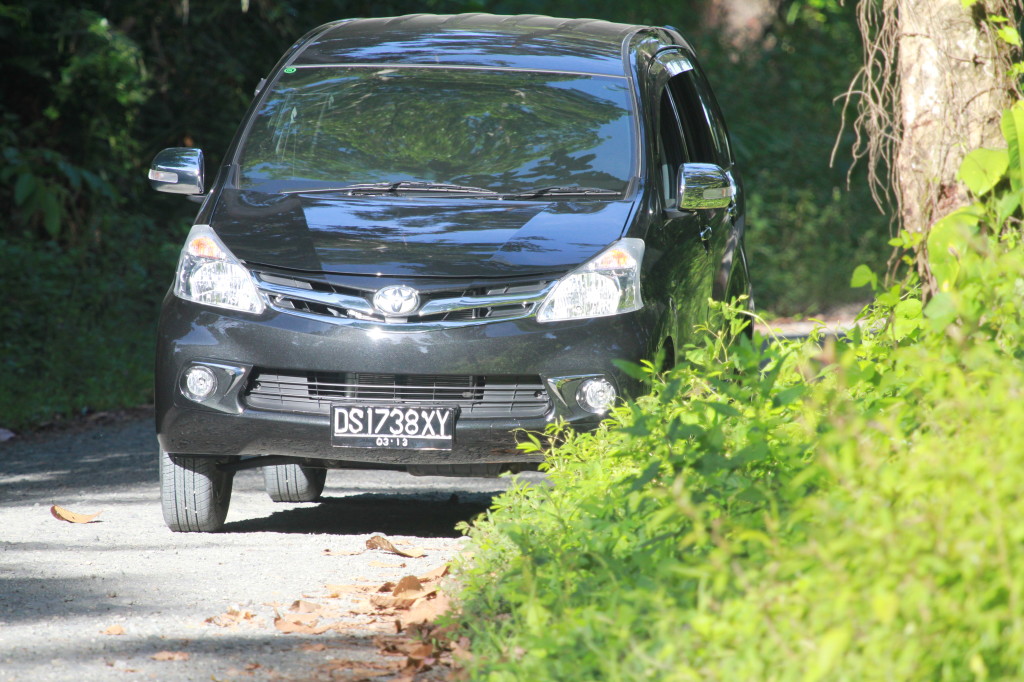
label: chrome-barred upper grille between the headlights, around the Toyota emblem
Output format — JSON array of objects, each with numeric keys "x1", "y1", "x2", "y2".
[{"x1": 256, "y1": 271, "x2": 553, "y2": 325}]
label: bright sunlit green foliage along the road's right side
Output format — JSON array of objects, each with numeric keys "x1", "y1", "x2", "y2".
[{"x1": 460, "y1": 98, "x2": 1024, "y2": 681}]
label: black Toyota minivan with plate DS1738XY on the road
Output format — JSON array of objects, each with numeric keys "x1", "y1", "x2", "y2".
[{"x1": 150, "y1": 14, "x2": 750, "y2": 531}]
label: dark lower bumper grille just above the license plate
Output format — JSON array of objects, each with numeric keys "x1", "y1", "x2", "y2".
[{"x1": 245, "y1": 370, "x2": 551, "y2": 419}]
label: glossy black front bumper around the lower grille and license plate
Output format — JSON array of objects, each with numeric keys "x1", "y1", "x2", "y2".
[{"x1": 156, "y1": 295, "x2": 655, "y2": 467}]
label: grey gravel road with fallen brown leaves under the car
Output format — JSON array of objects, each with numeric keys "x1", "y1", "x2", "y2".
[{"x1": 0, "y1": 416, "x2": 537, "y2": 682}]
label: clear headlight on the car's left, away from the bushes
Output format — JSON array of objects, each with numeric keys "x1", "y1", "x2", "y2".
[{"x1": 174, "y1": 225, "x2": 263, "y2": 313}]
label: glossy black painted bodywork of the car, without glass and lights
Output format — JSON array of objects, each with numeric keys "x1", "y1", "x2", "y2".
[{"x1": 157, "y1": 16, "x2": 745, "y2": 468}]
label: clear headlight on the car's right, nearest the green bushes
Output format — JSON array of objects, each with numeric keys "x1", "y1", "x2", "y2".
[{"x1": 537, "y1": 239, "x2": 643, "y2": 323}]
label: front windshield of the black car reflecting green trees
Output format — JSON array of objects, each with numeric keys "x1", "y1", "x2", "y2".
[{"x1": 239, "y1": 67, "x2": 635, "y2": 198}]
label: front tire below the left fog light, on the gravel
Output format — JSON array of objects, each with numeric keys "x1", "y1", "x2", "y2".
[{"x1": 160, "y1": 450, "x2": 234, "y2": 532}]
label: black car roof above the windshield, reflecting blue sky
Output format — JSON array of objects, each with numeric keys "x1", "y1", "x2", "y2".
[{"x1": 289, "y1": 13, "x2": 644, "y2": 76}]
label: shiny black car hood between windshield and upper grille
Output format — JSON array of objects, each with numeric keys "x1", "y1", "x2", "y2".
[{"x1": 211, "y1": 189, "x2": 633, "y2": 278}]
